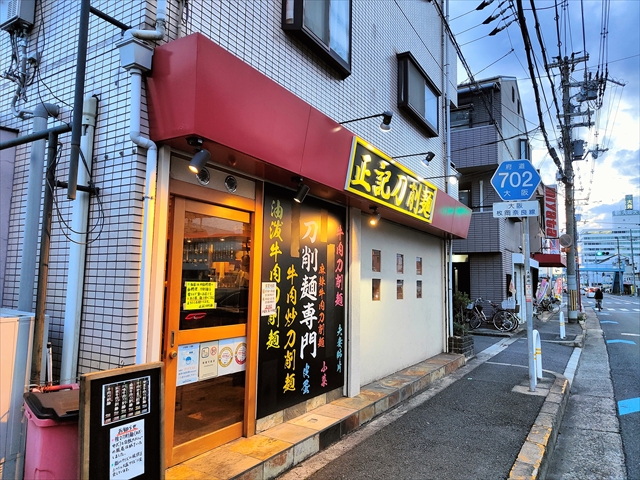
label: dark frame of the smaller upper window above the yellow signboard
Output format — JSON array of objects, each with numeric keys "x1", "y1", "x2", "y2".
[{"x1": 396, "y1": 52, "x2": 442, "y2": 137}]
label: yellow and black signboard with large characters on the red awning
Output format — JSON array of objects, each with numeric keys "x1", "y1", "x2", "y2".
[{"x1": 345, "y1": 137, "x2": 438, "y2": 223}]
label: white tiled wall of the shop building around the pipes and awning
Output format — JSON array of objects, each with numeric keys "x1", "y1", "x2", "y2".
[{"x1": 0, "y1": 0, "x2": 456, "y2": 380}]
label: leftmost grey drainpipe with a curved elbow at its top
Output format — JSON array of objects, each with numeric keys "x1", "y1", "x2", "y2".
[{"x1": 18, "y1": 103, "x2": 59, "y2": 312}]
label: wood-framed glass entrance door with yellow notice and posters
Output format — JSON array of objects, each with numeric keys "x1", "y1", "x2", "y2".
[{"x1": 164, "y1": 197, "x2": 251, "y2": 465}]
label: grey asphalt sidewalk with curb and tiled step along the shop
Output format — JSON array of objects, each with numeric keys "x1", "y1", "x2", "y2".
[{"x1": 166, "y1": 308, "x2": 583, "y2": 479}]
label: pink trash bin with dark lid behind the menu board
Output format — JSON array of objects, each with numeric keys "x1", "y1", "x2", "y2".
[{"x1": 24, "y1": 384, "x2": 80, "y2": 480}]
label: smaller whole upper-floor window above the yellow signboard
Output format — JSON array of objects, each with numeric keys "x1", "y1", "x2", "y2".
[{"x1": 398, "y1": 52, "x2": 440, "y2": 137}]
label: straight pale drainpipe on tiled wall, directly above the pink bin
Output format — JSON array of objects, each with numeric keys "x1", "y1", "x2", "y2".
[{"x1": 60, "y1": 96, "x2": 98, "y2": 385}]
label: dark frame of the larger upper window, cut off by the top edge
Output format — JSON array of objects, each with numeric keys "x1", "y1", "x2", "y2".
[{"x1": 282, "y1": 0, "x2": 353, "y2": 79}]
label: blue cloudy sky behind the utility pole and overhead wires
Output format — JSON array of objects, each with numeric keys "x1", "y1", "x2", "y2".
[{"x1": 449, "y1": 0, "x2": 640, "y2": 231}]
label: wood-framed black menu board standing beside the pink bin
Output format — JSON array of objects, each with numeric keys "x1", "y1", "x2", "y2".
[{"x1": 80, "y1": 362, "x2": 164, "y2": 480}]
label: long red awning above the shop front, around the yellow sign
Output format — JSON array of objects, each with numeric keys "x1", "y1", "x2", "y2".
[{"x1": 147, "y1": 33, "x2": 471, "y2": 238}]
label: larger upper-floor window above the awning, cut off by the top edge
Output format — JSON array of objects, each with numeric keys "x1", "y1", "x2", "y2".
[{"x1": 282, "y1": 0, "x2": 351, "y2": 78}]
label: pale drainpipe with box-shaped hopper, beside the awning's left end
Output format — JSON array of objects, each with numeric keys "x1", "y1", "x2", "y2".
[{"x1": 117, "y1": 0, "x2": 167, "y2": 364}]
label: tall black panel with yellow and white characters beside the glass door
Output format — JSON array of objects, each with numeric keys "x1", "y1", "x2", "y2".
[{"x1": 257, "y1": 185, "x2": 347, "y2": 418}]
